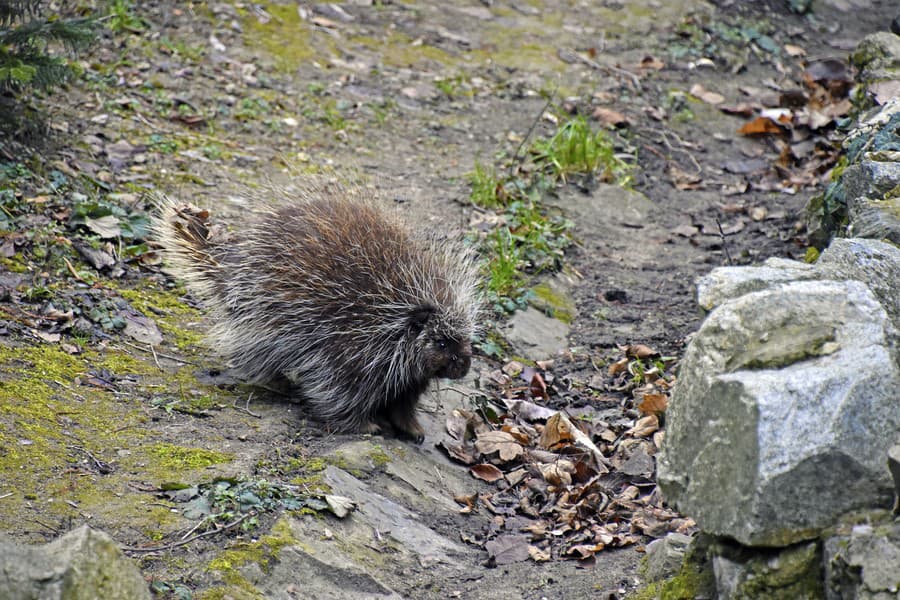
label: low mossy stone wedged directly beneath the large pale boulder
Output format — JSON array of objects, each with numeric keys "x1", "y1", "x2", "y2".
[{"x1": 713, "y1": 543, "x2": 823, "y2": 600}]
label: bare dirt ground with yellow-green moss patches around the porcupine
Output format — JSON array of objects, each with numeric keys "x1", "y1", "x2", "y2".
[{"x1": 0, "y1": 0, "x2": 893, "y2": 598}]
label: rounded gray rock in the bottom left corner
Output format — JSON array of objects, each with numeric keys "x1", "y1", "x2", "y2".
[{"x1": 0, "y1": 525, "x2": 150, "y2": 600}]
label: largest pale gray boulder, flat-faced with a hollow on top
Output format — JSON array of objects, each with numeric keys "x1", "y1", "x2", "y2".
[{"x1": 658, "y1": 281, "x2": 900, "y2": 546}]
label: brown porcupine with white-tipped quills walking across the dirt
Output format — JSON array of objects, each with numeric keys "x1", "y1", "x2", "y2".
[{"x1": 154, "y1": 184, "x2": 478, "y2": 442}]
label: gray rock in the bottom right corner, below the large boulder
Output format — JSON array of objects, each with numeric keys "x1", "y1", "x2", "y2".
[{"x1": 825, "y1": 520, "x2": 900, "y2": 600}]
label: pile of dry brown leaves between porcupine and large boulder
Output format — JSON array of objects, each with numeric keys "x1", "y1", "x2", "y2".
[{"x1": 439, "y1": 345, "x2": 694, "y2": 565}]
